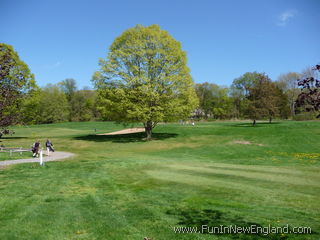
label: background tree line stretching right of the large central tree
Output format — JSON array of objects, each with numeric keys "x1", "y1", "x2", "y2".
[{"x1": 194, "y1": 65, "x2": 319, "y2": 124}]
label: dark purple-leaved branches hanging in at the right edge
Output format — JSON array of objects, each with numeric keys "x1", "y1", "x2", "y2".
[{"x1": 296, "y1": 65, "x2": 320, "y2": 118}]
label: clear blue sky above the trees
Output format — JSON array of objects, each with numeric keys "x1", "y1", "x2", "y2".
[{"x1": 0, "y1": 0, "x2": 320, "y2": 88}]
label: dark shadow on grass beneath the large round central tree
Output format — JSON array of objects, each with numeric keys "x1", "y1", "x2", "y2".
[{"x1": 74, "y1": 132, "x2": 178, "y2": 143}]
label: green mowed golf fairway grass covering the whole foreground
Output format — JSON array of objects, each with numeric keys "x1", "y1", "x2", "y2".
[{"x1": 0, "y1": 121, "x2": 320, "y2": 240}]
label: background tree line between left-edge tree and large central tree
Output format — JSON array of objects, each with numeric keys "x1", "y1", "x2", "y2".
[{"x1": 17, "y1": 78, "x2": 99, "y2": 124}]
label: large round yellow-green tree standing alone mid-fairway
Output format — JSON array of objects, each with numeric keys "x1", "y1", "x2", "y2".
[{"x1": 93, "y1": 25, "x2": 197, "y2": 140}]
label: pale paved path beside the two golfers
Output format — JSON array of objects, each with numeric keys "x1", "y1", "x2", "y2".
[{"x1": 0, "y1": 152, "x2": 74, "y2": 167}]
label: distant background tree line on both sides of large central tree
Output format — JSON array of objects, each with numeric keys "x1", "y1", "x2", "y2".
[{"x1": 11, "y1": 68, "x2": 315, "y2": 127}]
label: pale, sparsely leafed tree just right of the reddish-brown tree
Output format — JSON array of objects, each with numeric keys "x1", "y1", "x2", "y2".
[{"x1": 277, "y1": 72, "x2": 301, "y2": 116}]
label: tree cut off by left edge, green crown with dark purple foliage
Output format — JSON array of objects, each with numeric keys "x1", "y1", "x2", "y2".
[{"x1": 0, "y1": 43, "x2": 36, "y2": 137}]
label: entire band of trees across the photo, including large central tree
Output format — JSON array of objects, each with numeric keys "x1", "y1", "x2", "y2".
[{"x1": 0, "y1": 25, "x2": 320, "y2": 139}]
